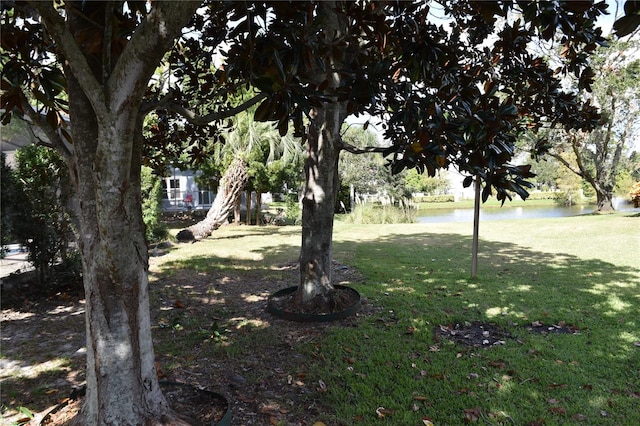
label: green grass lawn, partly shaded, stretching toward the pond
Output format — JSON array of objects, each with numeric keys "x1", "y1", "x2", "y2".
[{"x1": 161, "y1": 213, "x2": 640, "y2": 426}]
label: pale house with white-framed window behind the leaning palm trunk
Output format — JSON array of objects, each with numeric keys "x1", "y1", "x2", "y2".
[{"x1": 162, "y1": 167, "x2": 216, "y2": 212}]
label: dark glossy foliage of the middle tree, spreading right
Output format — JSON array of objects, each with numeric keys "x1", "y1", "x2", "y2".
[{"x1": 214, "y1": 2, "x2": 606, "y2": 204}]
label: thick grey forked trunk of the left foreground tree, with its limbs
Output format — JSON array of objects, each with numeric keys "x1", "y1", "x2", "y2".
[{"x1": 32, "y1": 2, "x2": 199, "y2": 426}]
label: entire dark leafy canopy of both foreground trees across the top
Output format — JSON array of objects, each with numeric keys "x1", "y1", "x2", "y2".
[{"x1": 2, "y1": 1, "x2": 606, "y2": 200}]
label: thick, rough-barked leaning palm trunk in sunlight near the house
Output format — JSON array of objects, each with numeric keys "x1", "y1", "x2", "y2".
[{"x1": 177, "y1": 158, "x2": 249, "y2": 241}]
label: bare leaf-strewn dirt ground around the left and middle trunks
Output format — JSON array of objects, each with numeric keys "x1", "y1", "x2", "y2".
[{"x1": 0, "y1": 258, "x2": 372, "y2": 426}]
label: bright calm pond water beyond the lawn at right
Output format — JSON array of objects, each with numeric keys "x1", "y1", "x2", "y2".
[{"x1": 416, "y1": 203, "x2": 638, "y2": 223}]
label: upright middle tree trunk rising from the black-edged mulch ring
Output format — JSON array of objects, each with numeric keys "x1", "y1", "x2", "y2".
[{"x1": 294, "y1": 1, "x2": 347, "y2": 310}]
